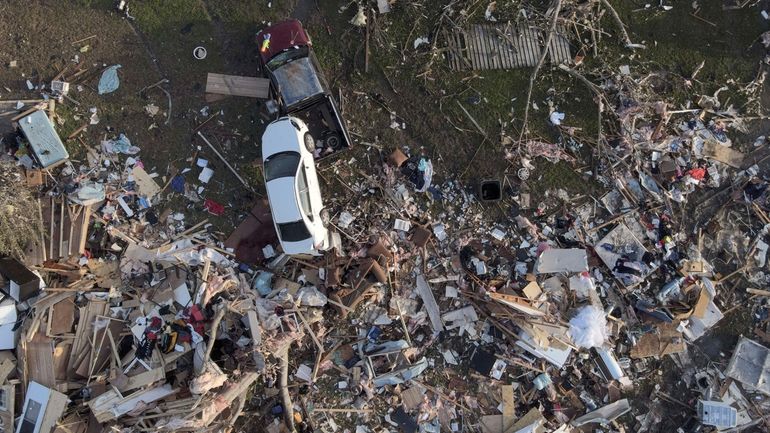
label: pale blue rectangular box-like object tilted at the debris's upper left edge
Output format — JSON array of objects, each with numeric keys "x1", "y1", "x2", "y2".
[{"x1": 19, "y1": 110, "x2": 69, "y2": 168}]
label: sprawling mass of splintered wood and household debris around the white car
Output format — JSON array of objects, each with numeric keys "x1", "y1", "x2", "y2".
[{"x1": 0, "y1": 1, "x2": 770, "y2": 433}]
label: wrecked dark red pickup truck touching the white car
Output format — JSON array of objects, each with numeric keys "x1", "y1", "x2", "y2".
[{"x1": 257, "y1": 20, "x2": 351, "y2": 159}]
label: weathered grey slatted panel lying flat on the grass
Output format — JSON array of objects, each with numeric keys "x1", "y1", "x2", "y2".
[{"x1": 444, "y1": 22, "x2": 572, "y2": 71}]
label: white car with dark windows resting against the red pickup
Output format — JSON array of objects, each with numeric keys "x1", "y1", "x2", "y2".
[{"x1": 262, "y1": 116, "x2": 330, "y2": 254}]
